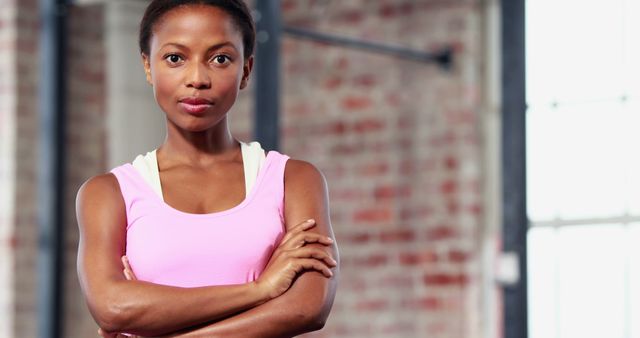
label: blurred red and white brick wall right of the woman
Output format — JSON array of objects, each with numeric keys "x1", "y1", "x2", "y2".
[{"x1": 282, "y1": 0, "x2": 490, "y2": 338}]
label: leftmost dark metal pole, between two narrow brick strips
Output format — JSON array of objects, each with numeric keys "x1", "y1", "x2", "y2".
[{"x1": 38, "y1": 0, "x2": 67, "y2": 338}]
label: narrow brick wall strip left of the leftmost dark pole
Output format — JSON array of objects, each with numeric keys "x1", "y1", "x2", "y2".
[{"x1": 13, "y1": 0, "x2": 40, "y2": 337}]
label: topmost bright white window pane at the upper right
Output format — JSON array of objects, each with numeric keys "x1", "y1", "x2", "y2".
[{"x1": 526, "y1": 0, "x2": 624, "y2": 104}]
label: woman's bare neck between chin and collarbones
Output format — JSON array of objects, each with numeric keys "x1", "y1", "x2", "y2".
[{"x1": 158, "y1": 117, "x2": 239, "y2": 166}]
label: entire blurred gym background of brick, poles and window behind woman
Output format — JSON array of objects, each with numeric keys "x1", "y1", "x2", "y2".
[{"x1": 0, "y1": 0, "x2": 640, "y2": 338}]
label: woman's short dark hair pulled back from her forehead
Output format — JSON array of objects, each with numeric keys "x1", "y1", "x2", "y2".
[{"x1": 138, "y1": 0, "x2": 256, "y2": 59}]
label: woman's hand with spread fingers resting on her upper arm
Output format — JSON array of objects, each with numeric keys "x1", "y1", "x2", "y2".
[{"x1": 256, "y1": 220, "x2": 337, "y2": 299}]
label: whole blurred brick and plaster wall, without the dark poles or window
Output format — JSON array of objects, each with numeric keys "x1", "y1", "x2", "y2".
[{"x1": 0, "y1": 0, "x2": 501, "y2": 338}]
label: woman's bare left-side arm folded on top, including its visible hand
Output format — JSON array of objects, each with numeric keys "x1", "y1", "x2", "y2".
[{"x1": 76, "y1": 174, "x2": 336, "y2": 336}]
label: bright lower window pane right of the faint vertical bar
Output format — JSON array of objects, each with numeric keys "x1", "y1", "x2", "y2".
[{"x1": 558, "y1": 225, "x2": 626, "y2": 338}]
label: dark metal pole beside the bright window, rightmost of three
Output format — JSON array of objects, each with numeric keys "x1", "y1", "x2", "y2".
[{"x1": 501, "y1": 0, "x2": 528, "y2": 338}]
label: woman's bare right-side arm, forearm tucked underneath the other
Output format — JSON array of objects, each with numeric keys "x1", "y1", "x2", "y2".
[{"x1": 161, "y1": 160, "x2": 339, "y2": 338}]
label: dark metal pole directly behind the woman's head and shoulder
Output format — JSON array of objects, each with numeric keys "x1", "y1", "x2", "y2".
[{"x1": 254, "y1": 0, "x2": 282, "y2": 150}]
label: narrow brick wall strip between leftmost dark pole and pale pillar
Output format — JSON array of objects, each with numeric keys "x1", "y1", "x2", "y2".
[{"x1": 64, "y1": 5, "x2": 108, "y2": 337}]
